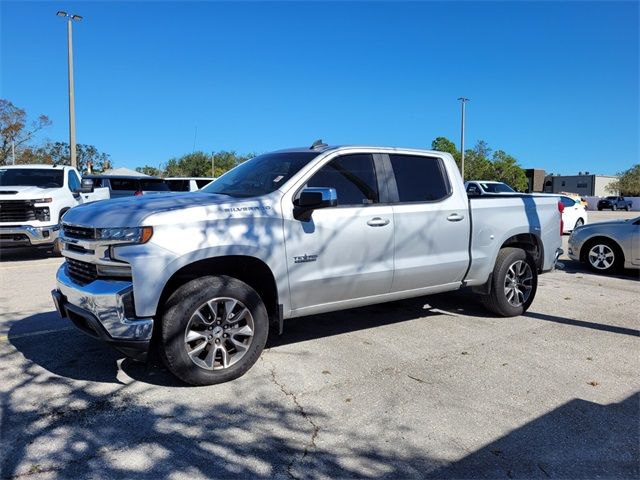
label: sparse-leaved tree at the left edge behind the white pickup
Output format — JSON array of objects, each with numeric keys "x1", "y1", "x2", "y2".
[{"x1": 0, "y1": 98, "x2": 51, "y2": 165}]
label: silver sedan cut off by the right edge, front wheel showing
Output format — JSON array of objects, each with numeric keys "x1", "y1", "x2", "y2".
[{"x1": 568, "y1": 217, "x2": 640, "y2": 273}]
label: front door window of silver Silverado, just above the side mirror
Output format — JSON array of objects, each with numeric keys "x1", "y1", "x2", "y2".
[{"x1": 307, "y1": 154, "x2": 379, "y2": 206}]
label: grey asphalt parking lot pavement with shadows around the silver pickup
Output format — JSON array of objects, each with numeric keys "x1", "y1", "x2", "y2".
[{"x1": 0, "y1": 212, "x2": 640, "y2": 479}]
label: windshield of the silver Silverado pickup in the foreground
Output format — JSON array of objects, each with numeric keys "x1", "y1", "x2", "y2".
[{"x1": 201, "y1": 151, "x2": 318, "y2": 198}]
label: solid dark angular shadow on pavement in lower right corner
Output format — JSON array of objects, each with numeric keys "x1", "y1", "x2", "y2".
[{"x1": 430, "y1": 393, "x2": 640, "y2": 479}]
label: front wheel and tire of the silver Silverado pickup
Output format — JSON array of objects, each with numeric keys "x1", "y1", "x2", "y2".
[{"x1": 159, "y1": 276, "x2": 269, "y2": 385}]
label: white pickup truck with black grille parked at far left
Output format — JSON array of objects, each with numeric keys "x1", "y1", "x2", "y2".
[{"x1": 0, "y1": 165, "x2": 109, "y2": 249}]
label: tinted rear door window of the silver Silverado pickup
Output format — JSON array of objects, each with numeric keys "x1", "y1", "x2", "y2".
[{"x1": 389, "y1": 155, "x2": 450, "y2": 202}]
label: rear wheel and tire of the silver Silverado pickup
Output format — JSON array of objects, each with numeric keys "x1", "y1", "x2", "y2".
[{"x1": 483, "y1": 247, "x2": 538, "y2": 317}]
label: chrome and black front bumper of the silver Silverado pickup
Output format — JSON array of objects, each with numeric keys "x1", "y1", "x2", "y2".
[{"x1": 51, "y1": 264, "x2": 153, "y2": 360}]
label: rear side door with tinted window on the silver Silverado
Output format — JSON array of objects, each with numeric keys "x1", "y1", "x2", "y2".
[{"x1": 385, "y1": 154, "x2": 470, "y2": 292}]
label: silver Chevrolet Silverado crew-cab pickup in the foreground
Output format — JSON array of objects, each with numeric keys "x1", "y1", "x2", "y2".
[{"x1": 52, "y1": 143, "x2": 561, "y2": 385}]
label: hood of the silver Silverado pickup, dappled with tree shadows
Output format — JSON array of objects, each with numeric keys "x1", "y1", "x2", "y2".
[{"x1": 64, "y1": 192, "x2": 255, "y2": 228}]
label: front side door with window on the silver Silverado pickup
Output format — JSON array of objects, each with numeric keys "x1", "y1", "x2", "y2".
[{"x1": 282, "y1": 154, "x2": 394, "y2": 310}]
